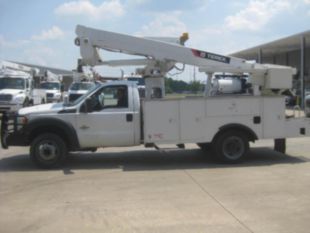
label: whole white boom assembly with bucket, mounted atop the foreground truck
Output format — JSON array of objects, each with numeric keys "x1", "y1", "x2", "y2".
[{"x1": 75, "y1": 25, "x2": 296, "y2": 95}]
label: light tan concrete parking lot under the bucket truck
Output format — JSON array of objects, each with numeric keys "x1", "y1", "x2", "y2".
[{"x1": 0, "y1": 138, "x2": 310, "y2": 233}]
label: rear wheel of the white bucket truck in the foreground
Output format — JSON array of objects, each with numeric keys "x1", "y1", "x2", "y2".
[{"x1": 214, "y1": 130, "x2": 249, "y2": 163}]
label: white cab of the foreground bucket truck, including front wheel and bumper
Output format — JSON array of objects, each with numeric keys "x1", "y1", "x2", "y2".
[{"x1": 1, "y1": 81, "x2": 141, "y2": 167}]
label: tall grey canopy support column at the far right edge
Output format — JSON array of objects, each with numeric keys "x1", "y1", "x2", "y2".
[{"x1": 299, "y1": 36, "x2": 306, "y2": 109}]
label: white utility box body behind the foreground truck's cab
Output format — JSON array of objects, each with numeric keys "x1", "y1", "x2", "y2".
[{"x1": 143, "y1": 96, "x2": 310, "y2": 144}]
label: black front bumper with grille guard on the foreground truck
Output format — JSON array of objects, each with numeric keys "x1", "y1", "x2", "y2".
[{"x1": 0, "y1": 113, "x2": 27, "y2": 149}]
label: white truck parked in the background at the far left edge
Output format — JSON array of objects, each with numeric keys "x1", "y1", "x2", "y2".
[{"x1": 0, "y1": 61, "x2": 46, "y2": 112}]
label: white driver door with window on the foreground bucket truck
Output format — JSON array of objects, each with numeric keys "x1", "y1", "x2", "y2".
[{"x1": 76, "y1": 85, "x2": 134, "y2": 148}]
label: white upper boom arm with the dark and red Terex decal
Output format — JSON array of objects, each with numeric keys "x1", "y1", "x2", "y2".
[{"x1": 76, "y1": 25, "x2": 254, "y2": 73}]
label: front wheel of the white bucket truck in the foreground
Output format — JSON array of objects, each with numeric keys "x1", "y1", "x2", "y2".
[{"x1": 30, "y1": 133, "x2": 68, "y2": 168}]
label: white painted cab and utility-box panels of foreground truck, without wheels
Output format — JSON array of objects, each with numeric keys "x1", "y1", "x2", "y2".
[{"x1": 8, "y1": 82, "x2": 310, "y2": 148}]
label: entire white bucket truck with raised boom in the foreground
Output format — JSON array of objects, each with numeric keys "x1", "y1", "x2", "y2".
[{"x1": 1, "y1": 26, "x2": 310, "y2": 168}]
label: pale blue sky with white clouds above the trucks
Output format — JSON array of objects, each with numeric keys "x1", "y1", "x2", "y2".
[{"x1": 0, "y1": 0, "x2": 310, "y2": 81}]
